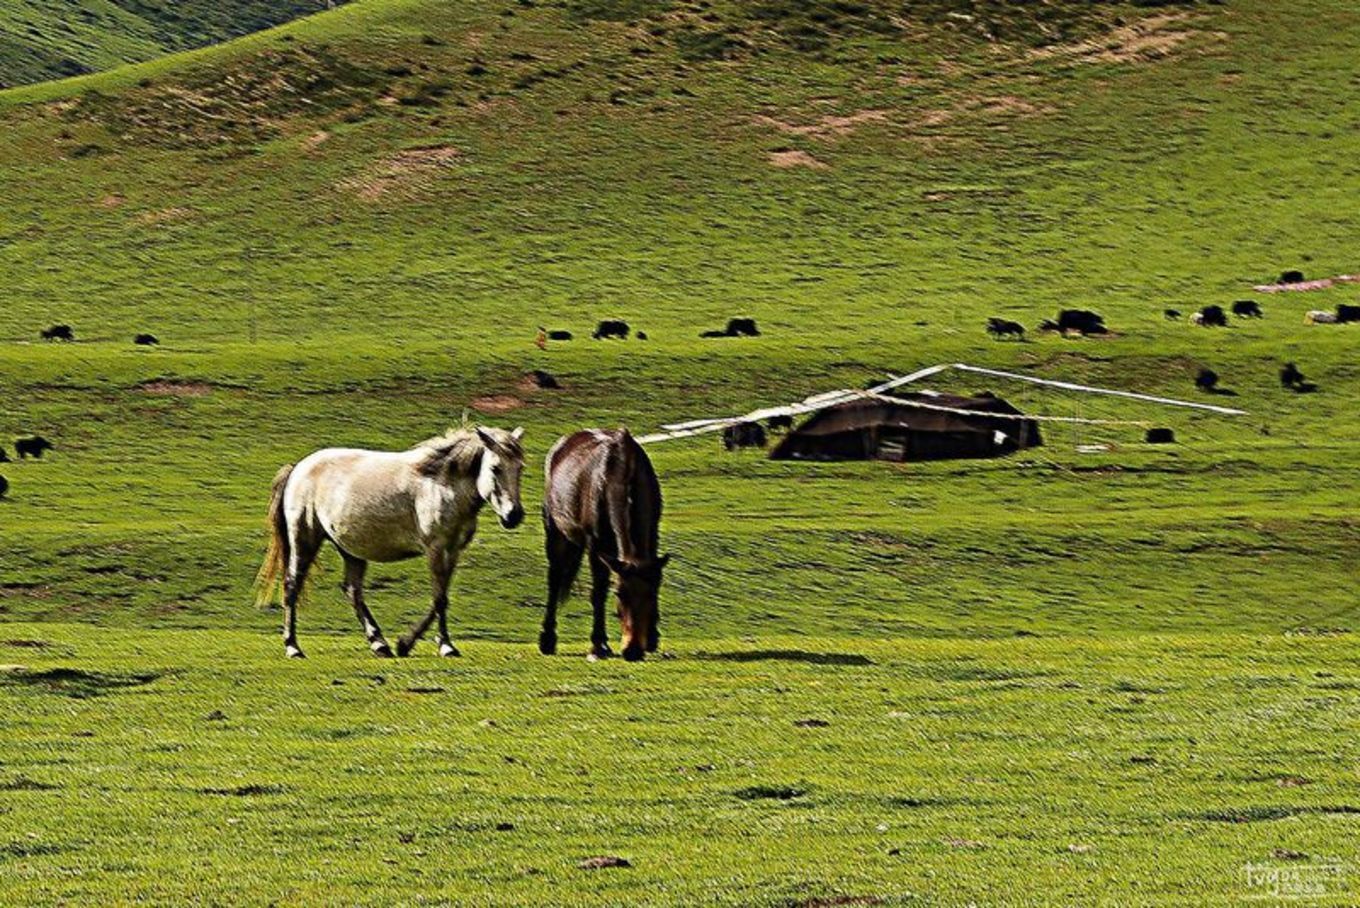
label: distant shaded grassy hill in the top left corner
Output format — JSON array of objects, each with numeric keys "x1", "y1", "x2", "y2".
[{"x1": 0, "y1": 0, "x2": 339, "y2": 88}]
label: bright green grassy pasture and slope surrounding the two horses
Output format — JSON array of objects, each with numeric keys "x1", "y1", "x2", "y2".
[{"x1": 0, "y1": 0, "x2": 1360, "y2": 905}]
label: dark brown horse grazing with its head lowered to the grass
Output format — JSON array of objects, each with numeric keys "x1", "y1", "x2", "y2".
[{"x1": 539, "y1": 428, "x2": 670, "y2": 662}]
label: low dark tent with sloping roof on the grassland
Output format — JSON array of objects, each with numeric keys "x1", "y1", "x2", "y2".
[{"x1": 770, "y1": 391, "x2": 1043, "y2": 462}]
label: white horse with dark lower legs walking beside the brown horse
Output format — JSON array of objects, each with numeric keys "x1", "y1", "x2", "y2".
[{"x1": 257, "y1": 427, "x2": 524, "y2": 658}]
